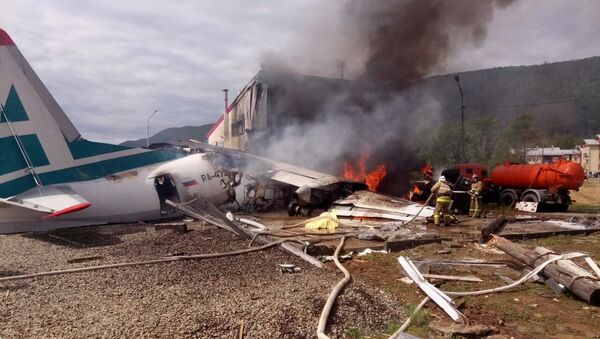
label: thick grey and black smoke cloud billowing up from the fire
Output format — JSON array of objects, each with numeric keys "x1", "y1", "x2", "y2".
[{"x1": 259, "y1": 0, "x2": 512, "y2": 195}]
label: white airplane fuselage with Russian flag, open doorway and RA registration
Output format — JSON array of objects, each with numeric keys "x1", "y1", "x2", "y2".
[{"x1": 0, "y1": 154, "x2": 235, "y2": 233}]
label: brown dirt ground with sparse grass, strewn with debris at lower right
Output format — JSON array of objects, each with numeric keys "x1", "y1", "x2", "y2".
[{"x1": 346, "y1": 233, "x2": 600, "y2": 338}]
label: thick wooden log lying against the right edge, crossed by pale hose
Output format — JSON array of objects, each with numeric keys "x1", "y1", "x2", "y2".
[{"x1": 492, "y1": 236, "x2": 600, "y2": 306}]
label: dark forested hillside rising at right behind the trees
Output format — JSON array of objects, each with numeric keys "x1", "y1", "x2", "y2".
[{"x1": 417, "y1": 57, "x2": 600, "y2": 137}]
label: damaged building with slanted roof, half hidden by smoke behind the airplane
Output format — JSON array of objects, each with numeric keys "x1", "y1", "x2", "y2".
[{"x1": 206, "y1": 69, "x2": 350, "y2": 153}]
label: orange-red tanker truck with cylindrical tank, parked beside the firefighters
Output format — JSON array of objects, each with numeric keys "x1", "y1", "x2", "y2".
[{"x1": 442, "y1": 159, "x2": 585, "y2": 214}]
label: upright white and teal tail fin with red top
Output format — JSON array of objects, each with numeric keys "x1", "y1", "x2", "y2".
[{"x1": 0, "y1": 29, "x2": 177, "y2": 198}]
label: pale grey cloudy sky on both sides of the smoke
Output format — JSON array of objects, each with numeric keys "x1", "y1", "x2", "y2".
[{"x1": 0, "y1": 0, "x2": 600, "y2": 143}]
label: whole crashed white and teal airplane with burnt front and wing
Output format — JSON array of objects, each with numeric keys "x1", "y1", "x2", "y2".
[{"x1": 0, "y1": 29, "x2": 431, "y2": 233}]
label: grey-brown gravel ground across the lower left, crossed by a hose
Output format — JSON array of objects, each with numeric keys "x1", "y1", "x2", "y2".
[{"x1": 0, "y1": 225, "x2": 404, "y2": 338}]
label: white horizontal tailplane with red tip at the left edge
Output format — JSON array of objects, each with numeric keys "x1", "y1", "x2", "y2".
[{"x1": 0, "y1": 187, "x2": 92, "y2": 219}]
